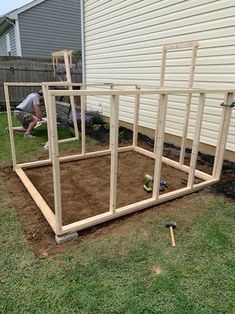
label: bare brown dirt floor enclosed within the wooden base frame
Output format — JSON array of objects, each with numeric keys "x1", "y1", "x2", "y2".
[{"x1": 22, "y1": 152, "x2": 187, "y2": 224}]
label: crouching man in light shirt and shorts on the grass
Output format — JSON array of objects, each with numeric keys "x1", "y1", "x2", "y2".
[{"x1": 14, "y1": 90, "x2": 43, "y2": 139}]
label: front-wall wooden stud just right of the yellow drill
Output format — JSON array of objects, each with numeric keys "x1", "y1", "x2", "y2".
[{"x1": 152, "y1": 94, "x2": 168, "y2": 200}]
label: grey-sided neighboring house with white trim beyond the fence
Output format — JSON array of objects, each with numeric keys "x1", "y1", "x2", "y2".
[{"x1": 0, "y1": 0, "x2": 81, "y2": 57}]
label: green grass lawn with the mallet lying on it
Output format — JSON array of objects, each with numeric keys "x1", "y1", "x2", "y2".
[{"x1": 0, "y1": 114, "x2": 235, "y2": 314}]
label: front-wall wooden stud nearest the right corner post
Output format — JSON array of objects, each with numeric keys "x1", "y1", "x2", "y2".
[{"x1": 188, "y1": 93, "x2": 206, "y2": 188}]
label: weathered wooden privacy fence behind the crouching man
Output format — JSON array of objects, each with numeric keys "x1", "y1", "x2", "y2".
[{"x1": 0, "y1": 57, "x2": 82, "y2": 111}]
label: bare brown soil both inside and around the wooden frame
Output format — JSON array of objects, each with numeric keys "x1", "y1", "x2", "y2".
[{"x1": 0, "y1": 140, "x2": 234, "y2": 258}]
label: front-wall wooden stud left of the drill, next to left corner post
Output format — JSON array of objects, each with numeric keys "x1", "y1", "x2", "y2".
[{"x1": 110, "y1": 95, "x2": 119, "y2": 213}]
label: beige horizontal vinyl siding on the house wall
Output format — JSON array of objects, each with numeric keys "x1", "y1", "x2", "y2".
[{"x1": 84, "y1": 0, "x2": 235, "y2": 151}]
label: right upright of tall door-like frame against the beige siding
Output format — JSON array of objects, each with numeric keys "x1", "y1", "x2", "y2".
[{"x1": 180, "y1": 45, "x2": 198, "y2": 165}]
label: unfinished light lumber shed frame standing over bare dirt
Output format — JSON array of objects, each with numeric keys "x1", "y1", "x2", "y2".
[{"x1": 4, "y1": 41, "x2": 235, "y2": 242}]
